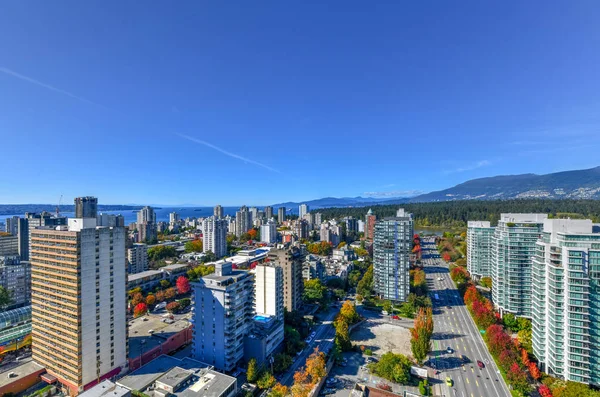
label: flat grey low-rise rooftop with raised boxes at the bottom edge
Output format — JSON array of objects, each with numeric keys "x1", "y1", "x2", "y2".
[{"x1": 117, "y1": 355, "x2": 237, "y2": 397}]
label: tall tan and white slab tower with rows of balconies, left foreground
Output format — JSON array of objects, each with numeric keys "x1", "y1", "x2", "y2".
[{"x1": 31, "y1": 198, "x2": 127, "y2": 395}]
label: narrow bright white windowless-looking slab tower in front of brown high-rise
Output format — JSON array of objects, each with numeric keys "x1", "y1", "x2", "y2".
[{"x1": 255, "y1": 263, "x2": 283, "y2": 321}]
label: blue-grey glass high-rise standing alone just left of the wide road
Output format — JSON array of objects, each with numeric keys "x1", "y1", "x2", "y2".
[{"x1": 373, "y1": 208, "x2": 413, "y2": 302}]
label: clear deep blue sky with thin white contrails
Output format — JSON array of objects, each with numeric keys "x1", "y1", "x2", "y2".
[{"x1": 0, "y1": 1, "x2": 600, "y2": 205}]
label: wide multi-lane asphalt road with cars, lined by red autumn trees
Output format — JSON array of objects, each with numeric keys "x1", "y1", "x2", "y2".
[{"x1": 422, "y1": 240, "x2": 510, "y2": 397}]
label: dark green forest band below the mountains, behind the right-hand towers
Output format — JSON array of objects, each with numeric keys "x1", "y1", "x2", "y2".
[{"x1": 319, "y1": 199, "x2": 600, "y2": 227}]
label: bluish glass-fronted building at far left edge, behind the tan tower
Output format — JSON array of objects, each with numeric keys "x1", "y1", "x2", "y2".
[{"x1": 0, "y1": 253, "x2": 31, "y2": 308}]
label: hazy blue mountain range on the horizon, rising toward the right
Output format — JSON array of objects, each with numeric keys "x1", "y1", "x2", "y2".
[{"x1": 273, "y1": 167, "x2": 600, "y2": 209}]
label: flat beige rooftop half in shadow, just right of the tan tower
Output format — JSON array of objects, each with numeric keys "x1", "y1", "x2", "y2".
[{"x1": 129, "y1": 314, "x2": 192, "y2": 358}]
